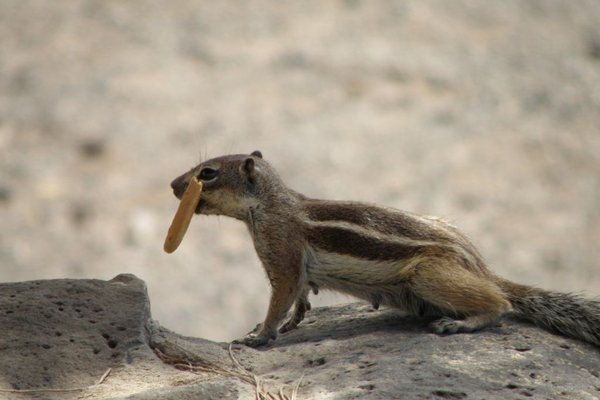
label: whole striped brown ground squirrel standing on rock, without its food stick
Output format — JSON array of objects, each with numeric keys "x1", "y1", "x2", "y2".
[{"x1": 171, "y1": 151, "x2": 600, "y2": 347}]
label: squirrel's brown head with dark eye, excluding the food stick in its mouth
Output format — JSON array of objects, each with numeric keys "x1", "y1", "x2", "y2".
[{"x1": 171, "y1": 150, "x2": 282, "y2": 220}]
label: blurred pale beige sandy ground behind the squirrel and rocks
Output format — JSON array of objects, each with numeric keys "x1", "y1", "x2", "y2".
[{"x1": 0, "y1": 0, "x2": 600, "y2": 340}]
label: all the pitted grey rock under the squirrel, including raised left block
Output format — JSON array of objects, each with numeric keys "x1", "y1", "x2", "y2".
[{"x1": 0, "y1": 275, "x2": 600, "y2": 400}]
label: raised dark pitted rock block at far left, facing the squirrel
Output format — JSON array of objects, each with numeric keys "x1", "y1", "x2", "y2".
[{"x1": 0, "y1": 275, "x2": 150, "y2": 389}]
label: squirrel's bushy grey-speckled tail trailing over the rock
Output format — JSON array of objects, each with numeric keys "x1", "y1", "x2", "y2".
[{"x1": 498, "y1": 280, "x2": 600, "y2": 346}]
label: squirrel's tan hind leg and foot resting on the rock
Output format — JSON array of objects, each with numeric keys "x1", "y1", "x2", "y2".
[{"x1": 409, "y1": 262, "x2": 512, "y2": 334}]
